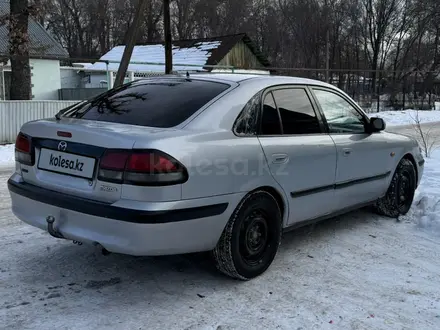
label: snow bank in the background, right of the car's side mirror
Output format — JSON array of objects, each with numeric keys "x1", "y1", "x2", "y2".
[{"x1": 368, "y1": 110, "x2": 440, "y2": 126}]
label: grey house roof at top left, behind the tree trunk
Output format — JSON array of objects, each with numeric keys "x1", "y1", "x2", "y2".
[{"x1": 0, "y1": 0, "x2": 69, "y2": 58}]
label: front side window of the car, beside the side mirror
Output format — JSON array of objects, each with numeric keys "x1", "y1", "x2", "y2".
[{"x1": 314, "y1": 90, "x2": 366, "y2": 133}]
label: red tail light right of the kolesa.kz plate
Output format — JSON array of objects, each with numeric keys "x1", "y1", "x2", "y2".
[{"x1": 98, "y1": 150, "x2": 188, "y2": 186}]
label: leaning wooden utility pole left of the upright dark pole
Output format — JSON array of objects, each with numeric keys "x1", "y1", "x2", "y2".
[{"x1": 110, "y1": 0, "x2": 147, "y2": 88}]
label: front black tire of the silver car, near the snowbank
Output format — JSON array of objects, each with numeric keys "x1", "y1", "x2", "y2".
[{"x1": 374, "y1": 159, "x2": 417, "y2": 218}]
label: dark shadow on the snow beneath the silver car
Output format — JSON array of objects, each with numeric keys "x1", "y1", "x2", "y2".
[{"x1": 9, "y1": 210, "x2": 380, "y2": 303}]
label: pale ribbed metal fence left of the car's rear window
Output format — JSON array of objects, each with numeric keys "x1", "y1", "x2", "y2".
[{"x1": 0, "y1": 101, "x2": 78, "y2": 143}]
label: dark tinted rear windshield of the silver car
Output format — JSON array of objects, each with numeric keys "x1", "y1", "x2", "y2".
[{"x1": 63, "y1": 79, "x2": 234, "y2": 127}]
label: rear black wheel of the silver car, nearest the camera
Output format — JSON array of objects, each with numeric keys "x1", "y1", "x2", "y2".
[{"x1": 213, "y1": 190, "x2": 282, "y2": 281}]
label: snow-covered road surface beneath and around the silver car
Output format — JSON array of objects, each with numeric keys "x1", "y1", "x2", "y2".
[{"x1": 0, "y1": 123, "x2": 440, "y2": 330}]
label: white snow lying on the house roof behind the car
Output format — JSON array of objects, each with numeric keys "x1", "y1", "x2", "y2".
[{"x1": 81, "y1": 41, "x2": 221, "y2": 72}]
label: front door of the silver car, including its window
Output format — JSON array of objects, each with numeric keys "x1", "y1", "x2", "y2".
[{"x1": 313, "y1": 87, "x2": 394, "y2": 208}]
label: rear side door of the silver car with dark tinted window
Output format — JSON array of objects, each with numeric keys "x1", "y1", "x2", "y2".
[{"x1": 259, "y1": 86, "x2": 336, "y2": 225}]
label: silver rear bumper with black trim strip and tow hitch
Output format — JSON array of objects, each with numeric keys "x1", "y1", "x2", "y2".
[{"x1": 8, "y1": 175, "x2": 241, "y2": 256}]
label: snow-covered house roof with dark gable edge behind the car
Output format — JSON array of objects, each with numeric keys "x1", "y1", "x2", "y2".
[{"x1": 84, "y1": 33, "x2": 269, "y2": 72}]
